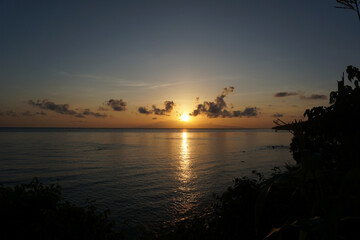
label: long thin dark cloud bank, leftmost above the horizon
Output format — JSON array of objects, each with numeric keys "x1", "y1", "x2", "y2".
[{"x1": 25, "y1": 99, "x2": 107, "y2": 118}]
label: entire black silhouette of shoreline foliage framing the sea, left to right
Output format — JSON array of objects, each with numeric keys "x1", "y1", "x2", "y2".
[{"x1": 0, "y1": 66, "x2": 360, "y2": 240}]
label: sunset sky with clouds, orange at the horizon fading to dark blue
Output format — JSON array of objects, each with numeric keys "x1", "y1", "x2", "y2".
[{"x1": 0, "y1": 0, "x2": 360, "y2": 128}]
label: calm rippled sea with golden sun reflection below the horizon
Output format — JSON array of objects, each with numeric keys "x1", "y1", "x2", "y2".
[{"x1": 0, "y1": 129, "x2": 293, "y2": 230}]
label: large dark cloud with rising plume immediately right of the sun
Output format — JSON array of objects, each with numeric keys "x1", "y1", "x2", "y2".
[{"x1": 190, "y1": 86, "x2": 258, "y2": 118}]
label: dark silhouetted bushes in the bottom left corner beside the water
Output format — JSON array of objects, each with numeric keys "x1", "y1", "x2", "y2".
[{"x1": 0, "y1": 178, "x2": 121, "y2": 239}]
